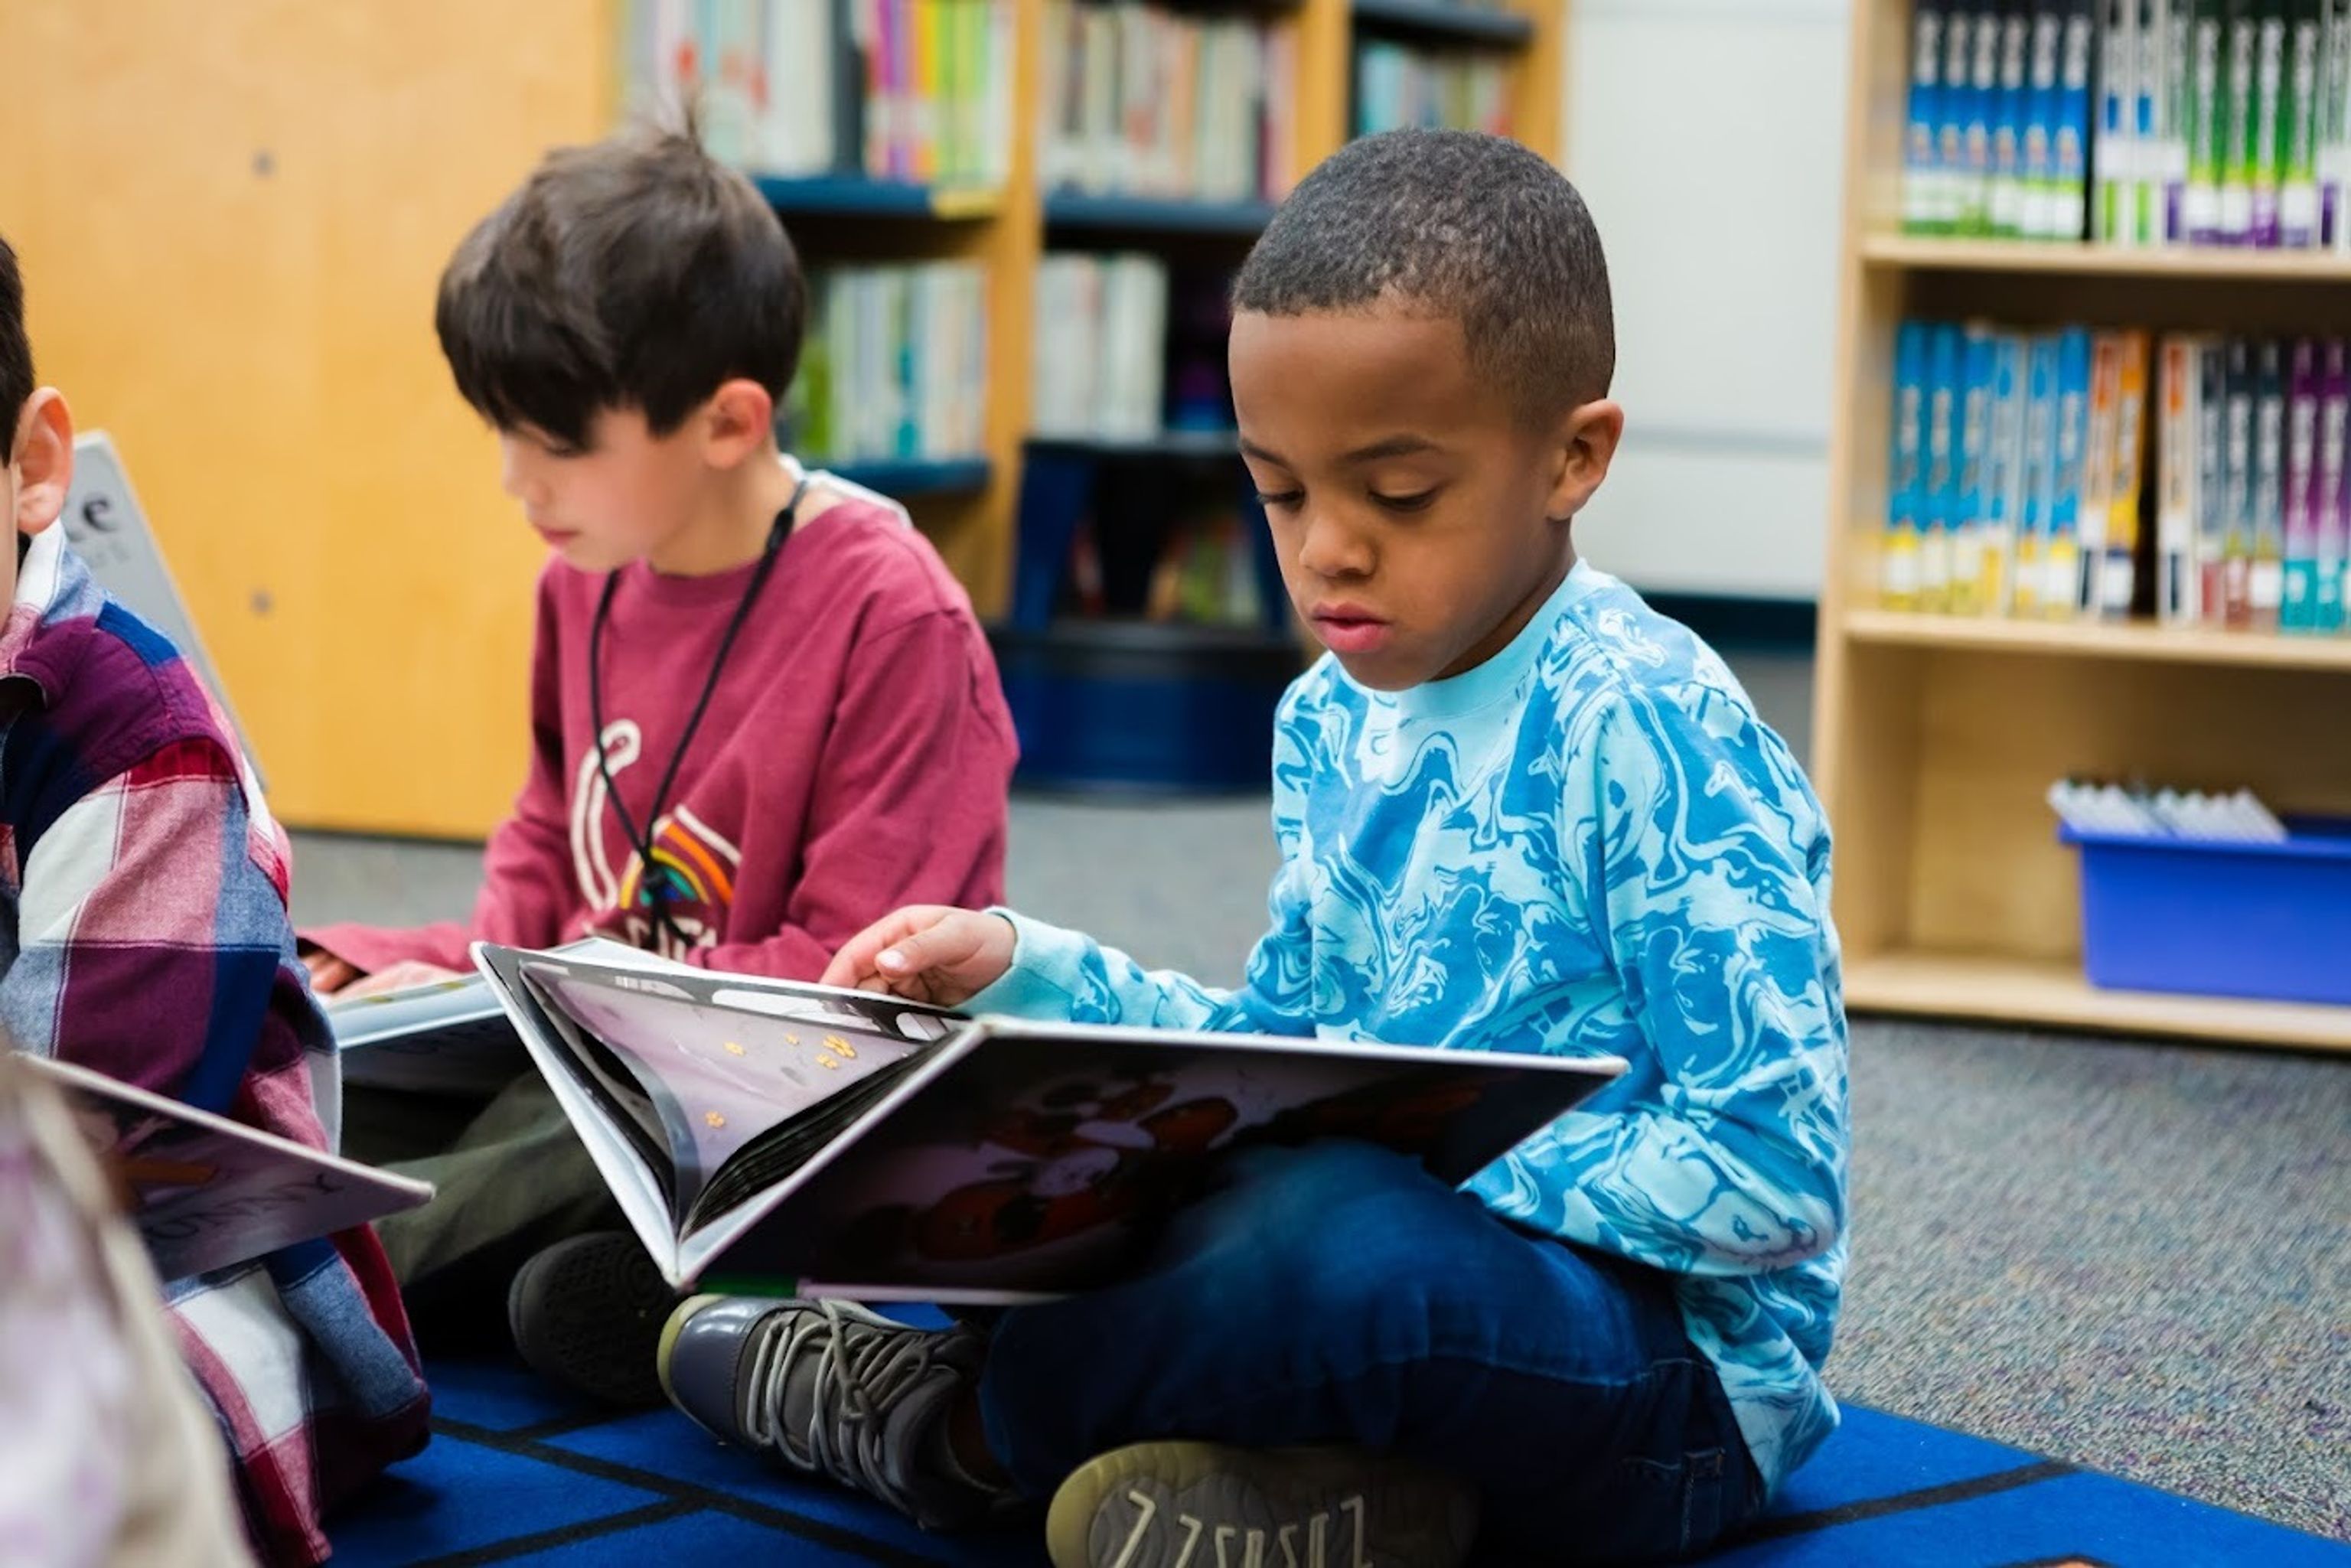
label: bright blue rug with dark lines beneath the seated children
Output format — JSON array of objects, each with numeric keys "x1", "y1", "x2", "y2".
[{"x1": 334, "y1": 1364, "x2": 2351, "y2": 1568}]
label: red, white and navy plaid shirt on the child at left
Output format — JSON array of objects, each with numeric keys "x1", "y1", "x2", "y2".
[{"x1": 0, "y1": 526, "x2": 430, "y2": 1563}]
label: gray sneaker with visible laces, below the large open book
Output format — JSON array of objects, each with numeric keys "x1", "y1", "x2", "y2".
[{"x1": 658, "y1": 1296, "x2": 1006, "y2": 1531}]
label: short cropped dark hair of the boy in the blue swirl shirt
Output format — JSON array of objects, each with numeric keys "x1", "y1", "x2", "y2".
[{"x1": 1232, "y1": 129, "x2": 1615, "y2": 419}]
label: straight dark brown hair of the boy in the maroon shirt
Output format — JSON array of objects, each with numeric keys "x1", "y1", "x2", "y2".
[{"x1": 435, "y1": 127, "x2": 809, "y2": 445}]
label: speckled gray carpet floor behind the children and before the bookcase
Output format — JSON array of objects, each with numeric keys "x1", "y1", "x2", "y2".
[{"x1": 294, "y1": 656, "x2": 2351, "y2": 1540}]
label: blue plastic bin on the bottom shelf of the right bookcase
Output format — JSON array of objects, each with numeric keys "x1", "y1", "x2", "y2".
[{"x1": 2057, "y1": 818, "x2": 2351, "y2": 1004}]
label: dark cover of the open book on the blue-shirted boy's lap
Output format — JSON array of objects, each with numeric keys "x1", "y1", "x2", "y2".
[{"x1": 684, "y1": 1018, "x2": 1625, "y2": 1300}]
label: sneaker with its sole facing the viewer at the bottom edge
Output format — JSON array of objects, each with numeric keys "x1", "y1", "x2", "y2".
[{"x1": 1044, "y1": 1443, "x2": 1476, "y2": 1568}]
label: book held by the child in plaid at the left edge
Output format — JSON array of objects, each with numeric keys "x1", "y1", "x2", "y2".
[{"x1": 17, "y1": 1055, "x2": 432, "y2": 1283}]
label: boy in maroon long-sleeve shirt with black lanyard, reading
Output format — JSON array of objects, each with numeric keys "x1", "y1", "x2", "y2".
[{"x1": 305, "y1": 132, "x2": 1016, "y2": 1399}]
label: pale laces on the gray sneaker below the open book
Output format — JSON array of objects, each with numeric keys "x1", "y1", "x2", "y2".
[{"x1": 743, "y1": 1300, "x2": 964, "y2": 1514}]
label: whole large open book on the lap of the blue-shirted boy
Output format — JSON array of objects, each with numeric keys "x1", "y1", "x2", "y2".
[{"x1": 472, "y1": 943, "x2": 1625, "y2": 1302}]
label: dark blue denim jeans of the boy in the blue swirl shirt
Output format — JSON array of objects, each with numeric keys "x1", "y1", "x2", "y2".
[{"x1": 980, "y1": 1143, "x2": 1763, "y2": 1563}]
